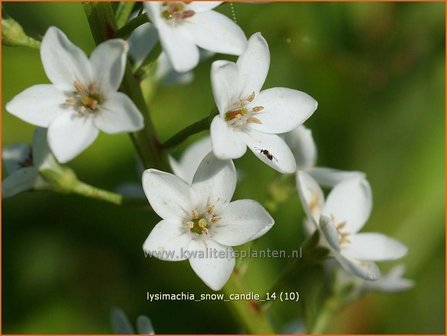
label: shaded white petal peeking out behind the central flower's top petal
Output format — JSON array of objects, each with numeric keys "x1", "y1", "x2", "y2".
[{"x1": 168, "y1": 136, "x2": 212, "y2": 183}]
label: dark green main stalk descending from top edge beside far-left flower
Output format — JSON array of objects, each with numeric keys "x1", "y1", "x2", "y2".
[{"x1": 83, "y1": 2, "x2": 170, "y2": 170}]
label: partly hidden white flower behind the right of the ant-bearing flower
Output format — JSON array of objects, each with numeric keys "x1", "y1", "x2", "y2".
[{"x1": 284, "y1": 126, "x2": 365, "y2": 188}]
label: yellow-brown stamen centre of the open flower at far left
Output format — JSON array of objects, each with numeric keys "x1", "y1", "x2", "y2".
[{"x1": 65, "y1": 81, "x2": 104, "y2": 115}]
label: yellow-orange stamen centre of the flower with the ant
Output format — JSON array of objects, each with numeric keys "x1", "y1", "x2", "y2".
[{"x1": 224, "y1": 92, "x2": 264, "y2": 127}]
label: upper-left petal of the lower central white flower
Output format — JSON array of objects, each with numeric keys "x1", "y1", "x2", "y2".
[{"x1": 143, "y1": 169, "x2": 193, "y2": 220}]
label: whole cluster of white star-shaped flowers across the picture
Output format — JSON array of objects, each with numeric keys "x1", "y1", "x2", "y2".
[{"x1": 3, "y1": 2, "x2": 407, "y2": 290}]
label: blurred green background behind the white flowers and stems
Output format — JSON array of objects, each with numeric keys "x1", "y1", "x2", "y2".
[{"x1": 2, "y1": 3, "x2": 445, "y2": 333}]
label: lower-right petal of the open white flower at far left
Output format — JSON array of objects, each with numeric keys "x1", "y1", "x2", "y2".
[{"x1": 94, "y1": 92, "x2": 144, "y2": 134}]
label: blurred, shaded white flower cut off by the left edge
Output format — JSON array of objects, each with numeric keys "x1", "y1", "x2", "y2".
[{"x1": 2, "y1": 128, "x2": 58, "y2": 198}]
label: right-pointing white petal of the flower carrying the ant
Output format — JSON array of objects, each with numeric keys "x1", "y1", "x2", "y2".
[{"x1": 250, "y1": 88, "x2": 318, "y2": 134}]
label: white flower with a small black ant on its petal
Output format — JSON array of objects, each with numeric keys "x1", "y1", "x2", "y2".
[{"x1": 211, "y1": 33, "x2": 317, "y2": 173}]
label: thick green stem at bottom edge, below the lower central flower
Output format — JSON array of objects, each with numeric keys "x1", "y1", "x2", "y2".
[{"x1": 223, "y1": 269, "x2": 275, "y2": 334}]
